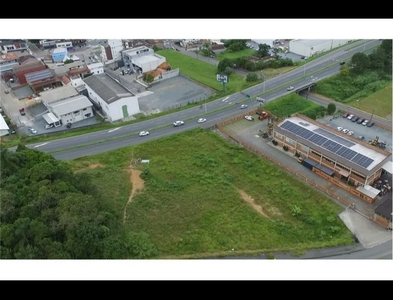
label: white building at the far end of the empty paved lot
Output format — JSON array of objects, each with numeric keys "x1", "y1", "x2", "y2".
[{"x1": 122, "y1": 46, "x2": 166, "y2": 73}]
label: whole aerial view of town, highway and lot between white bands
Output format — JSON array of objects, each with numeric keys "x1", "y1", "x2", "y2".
[{"x1": 0, "y1": 30, "x2": 393, "y2": 276}]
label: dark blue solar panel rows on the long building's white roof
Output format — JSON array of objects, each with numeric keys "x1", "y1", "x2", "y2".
[{"x1": 281, "y1": 121, "x2": 374, "y2": 168}]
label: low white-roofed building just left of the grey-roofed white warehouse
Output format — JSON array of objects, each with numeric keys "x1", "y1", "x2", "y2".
[{"x1": 45, "y1": 95, "x2": 94, "y2": 125}]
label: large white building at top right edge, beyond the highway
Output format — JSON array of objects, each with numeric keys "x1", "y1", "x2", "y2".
[{"x1": 289, "y1": 40, "x2": 351, "y2": 57}]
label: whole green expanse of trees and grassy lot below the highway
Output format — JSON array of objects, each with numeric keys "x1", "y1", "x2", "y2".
[{"x1": 0, "y1": 128, "x2": 353, "y2": 259}]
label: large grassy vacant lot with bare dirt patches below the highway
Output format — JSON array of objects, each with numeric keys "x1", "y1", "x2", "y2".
[{"x1": 70, "y1": 128, "x2": 353, "y2": 258}]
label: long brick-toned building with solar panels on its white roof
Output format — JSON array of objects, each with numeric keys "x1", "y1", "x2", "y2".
[{"x1": 273, "y1": 114, "x2": 392, "y2": 203}]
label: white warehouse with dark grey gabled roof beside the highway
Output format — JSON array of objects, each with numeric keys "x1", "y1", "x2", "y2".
[{"x1": 84, "y1": 74, "x2": 140, "y2": 122}]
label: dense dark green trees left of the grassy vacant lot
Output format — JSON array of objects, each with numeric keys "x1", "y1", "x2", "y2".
[{"x1": 0, "y1": 146, "x2": 155, "y2": 259}]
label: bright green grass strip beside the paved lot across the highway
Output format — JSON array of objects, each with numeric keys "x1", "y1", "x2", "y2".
[{"x1": 157, "y1": 50, "x2": 255, "y2": 94}]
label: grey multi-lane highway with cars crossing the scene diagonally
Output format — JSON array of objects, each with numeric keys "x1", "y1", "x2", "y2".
[{"x1": 18, "y1": 40, "x2": 381, "y2": 160}]
